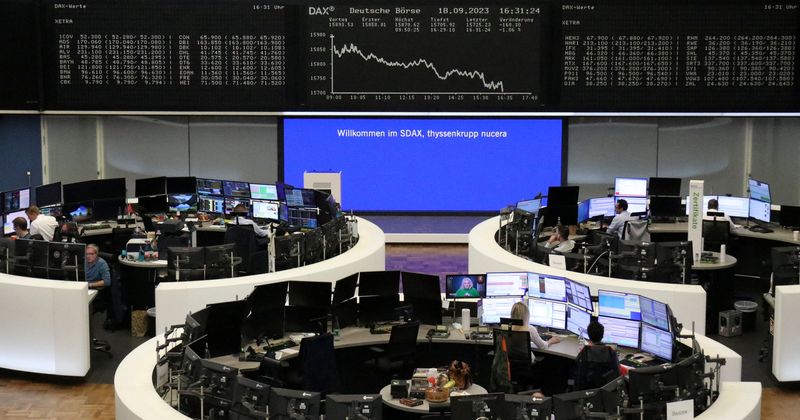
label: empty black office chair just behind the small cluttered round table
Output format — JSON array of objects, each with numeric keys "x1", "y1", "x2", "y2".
[{"x1": 367, "y1": 321, "x2": 419, "y2": 378}]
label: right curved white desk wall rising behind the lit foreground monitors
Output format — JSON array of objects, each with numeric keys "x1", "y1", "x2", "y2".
[{"x1": 469, "y1": 220, "x2": 706, "y2": 334}]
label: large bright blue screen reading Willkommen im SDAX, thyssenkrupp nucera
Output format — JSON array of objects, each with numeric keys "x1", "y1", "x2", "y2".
[{"x1": 283, "y1": 118, "x2": 562, "y2": 211}]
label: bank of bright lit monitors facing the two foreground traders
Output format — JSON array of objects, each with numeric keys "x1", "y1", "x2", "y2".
[{"x1": 480, "y1": 272, "x2": 674, "y2": 361}]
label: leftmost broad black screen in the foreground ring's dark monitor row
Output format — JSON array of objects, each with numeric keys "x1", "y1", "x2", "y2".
[{"x1": 206, "y1": 300, "x2": 248, "y2": 357}]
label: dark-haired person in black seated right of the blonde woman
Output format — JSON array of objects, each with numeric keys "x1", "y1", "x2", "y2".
[{"x1": 573, "y1": 321, "x2": 619, "y2": 391}]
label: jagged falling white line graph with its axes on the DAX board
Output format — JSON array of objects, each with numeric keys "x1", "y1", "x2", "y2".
[{"x1": 330, "y1": 34, "x2": 532, "y2": 95}]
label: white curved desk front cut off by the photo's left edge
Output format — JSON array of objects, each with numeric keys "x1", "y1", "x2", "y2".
[{"x1": 0, "y1": 274, "x2": 91, "y2": 376}]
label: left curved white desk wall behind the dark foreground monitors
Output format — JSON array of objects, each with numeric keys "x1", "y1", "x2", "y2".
[{"x1": 156, "y1": 218, "x2": 386, "y2": 332}]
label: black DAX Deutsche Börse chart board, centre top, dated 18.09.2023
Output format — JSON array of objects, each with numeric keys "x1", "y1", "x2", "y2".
[{"x1": 307, "y1": 4, "x2": 545, "y2": 109}]
